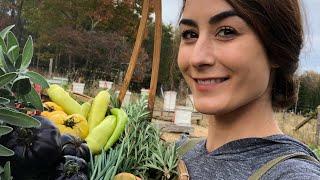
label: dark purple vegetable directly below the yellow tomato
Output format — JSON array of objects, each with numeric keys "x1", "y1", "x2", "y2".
[{"x1": 61, "y1": 134, "x2": 90, "y2": 162}]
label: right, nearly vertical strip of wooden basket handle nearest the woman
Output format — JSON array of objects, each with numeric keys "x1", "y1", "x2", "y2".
[{"x1": 148, "y1": 0, "x2": 162, "y2": 116}]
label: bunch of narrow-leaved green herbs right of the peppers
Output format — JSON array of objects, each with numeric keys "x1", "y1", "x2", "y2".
[{"x1": 90, "y1": 98, "x2": 178, "y2": 180}]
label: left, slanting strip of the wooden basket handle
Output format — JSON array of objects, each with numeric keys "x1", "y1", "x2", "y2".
[{"x1": 118, "y1": 0, "x2": 149, "y2": 105}]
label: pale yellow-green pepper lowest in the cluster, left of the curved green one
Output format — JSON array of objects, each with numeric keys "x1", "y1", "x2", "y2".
[{"x1": 86, "y1": 115, "x2": 117, "y2": 154}]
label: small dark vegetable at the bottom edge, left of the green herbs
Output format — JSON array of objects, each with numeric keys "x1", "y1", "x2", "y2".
[{"x1": 55, "y1": 155, "x2": 88, "y2": 180}]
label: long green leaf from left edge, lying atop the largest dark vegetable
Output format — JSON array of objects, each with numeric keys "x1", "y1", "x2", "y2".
[{"x1": 0, "y1": 108, "x2": 40, "y2": 128}]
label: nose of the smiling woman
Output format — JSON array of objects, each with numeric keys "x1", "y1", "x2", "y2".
[{"x1": 190, "y1": 36, "x2": 215, "y2": 68}]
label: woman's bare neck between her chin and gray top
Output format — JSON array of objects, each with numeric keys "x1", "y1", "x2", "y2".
[{"x1": 206, "y1": 94, "x2": 282, "y2": 152}]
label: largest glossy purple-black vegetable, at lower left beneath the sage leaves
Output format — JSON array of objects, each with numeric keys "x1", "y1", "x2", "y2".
[{"x1": 2, "y1": 116, "x2": 61, "y2": 179}]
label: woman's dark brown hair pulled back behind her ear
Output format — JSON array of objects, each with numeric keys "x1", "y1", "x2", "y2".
[{"x1": 182, "y1": 0, "x2": 303, "y2": 109}]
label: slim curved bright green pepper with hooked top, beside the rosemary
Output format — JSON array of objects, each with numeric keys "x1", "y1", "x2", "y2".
[{"x1": 104, "y1": 108, "x2": 128, "y2": 151}]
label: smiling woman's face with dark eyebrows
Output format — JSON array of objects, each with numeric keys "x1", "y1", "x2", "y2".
[{"x1": 178, "y1": 0, "x2": 271, "y2": 115}]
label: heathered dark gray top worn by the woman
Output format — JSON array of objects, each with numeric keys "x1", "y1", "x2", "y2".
[{"x1": 178, "y1": 135, "x2": 320, "y2": 180}]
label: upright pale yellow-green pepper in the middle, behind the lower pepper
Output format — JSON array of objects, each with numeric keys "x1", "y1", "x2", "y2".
[{"x1": 88, "y1": 90, "x2": 110, "y2": 132}]
